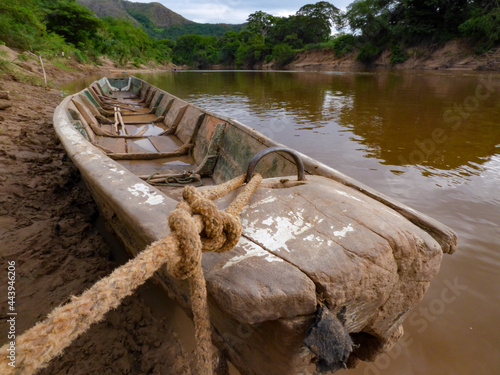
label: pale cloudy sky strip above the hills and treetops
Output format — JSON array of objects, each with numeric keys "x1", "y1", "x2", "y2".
[{"x1": 130, "y1": 0, "x2": 353, "y2": 24}]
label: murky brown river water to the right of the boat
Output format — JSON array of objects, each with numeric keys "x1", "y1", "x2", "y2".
[{"x1": 64, "y1": 71, "x2": 500, "y2": 375}]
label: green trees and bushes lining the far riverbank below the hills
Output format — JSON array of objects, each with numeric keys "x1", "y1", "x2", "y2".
[{"x1": 0, "y1": 0, "x2": 500, "y2": 70}]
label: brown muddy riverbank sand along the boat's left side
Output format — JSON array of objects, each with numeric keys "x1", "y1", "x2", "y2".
[{"x1": 0, "y1": 77, "x2": 193, "y2": 375}]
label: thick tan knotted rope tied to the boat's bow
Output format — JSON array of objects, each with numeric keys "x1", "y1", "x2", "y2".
[{"x1": 0, "y1": 174, "x2": 262, "y2": 375}]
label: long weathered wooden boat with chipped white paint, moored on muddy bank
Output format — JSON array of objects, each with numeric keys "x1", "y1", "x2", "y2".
[{"x1": 54, "y1": 77, "x2": 457, "y2": 374}]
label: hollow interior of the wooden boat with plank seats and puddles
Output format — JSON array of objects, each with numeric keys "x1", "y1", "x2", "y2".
[{"x1": 68, "y1": 77, "x2": 297, "y2": 195}]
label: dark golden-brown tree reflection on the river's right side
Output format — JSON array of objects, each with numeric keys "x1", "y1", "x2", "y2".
[{"x1": 339, "y1": 74, "x2": 500, "y2": 175}]
